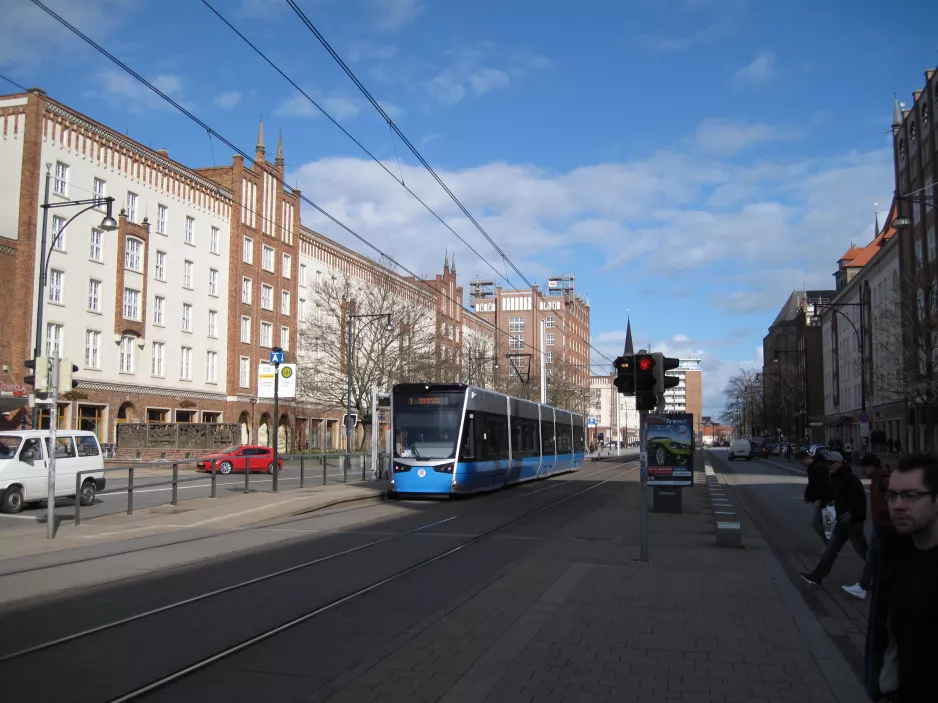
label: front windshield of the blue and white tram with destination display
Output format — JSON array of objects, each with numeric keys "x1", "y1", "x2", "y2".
[{"x1": 394, "y1": 392, "x2": 466, "y2": 461}]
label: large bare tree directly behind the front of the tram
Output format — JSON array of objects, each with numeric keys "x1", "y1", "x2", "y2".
[{"x1": 297, "y1": 268, "x2": 437, "y2": 452}]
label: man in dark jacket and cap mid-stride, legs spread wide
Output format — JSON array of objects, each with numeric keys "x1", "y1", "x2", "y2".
[{"x1": 801, "y1": 451, "x2": 869, "y2": 586}]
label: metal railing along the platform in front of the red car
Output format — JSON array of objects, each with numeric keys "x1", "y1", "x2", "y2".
[{"x1": 75, "y1": 453, "x2": 372, "y2": 525}]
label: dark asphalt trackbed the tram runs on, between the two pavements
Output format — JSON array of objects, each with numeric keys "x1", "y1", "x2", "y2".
[{"x1": 0, "y1": 461, "x2": 634, "y2": 703}]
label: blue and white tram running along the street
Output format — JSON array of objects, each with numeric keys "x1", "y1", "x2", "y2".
[{"x1": 391, "y1": 383, "x2": 586, "y2": 495}]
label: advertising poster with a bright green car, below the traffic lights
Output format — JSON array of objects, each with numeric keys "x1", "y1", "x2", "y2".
[{"x1": 646, "y1": 413, "x2": 694, "y2": 486}]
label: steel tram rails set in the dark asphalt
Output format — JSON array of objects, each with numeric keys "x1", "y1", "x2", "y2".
[{"x1": 0, "y1": 461, "x2": 635, "y2": 701}]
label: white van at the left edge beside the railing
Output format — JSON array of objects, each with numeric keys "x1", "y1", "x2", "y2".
[{"x1": 0, "y1": 430, "x2": 107, "y2": 513}]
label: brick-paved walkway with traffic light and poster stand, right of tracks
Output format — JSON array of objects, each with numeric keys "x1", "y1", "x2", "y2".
[{"x1": 322, "y1": 462, "x2": 866, "y2": 703}]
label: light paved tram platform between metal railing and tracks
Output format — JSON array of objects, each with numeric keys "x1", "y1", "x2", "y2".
[{"x1": 0, "y1": 481, "x2": 389, "y2": 603}]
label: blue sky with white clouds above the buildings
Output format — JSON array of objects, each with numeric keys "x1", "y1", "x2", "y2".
[{"x1": 0, "y1": 0, "x2": 938, "y2": 414}]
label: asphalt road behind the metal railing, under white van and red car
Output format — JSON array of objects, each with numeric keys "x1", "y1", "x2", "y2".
[{"x1": 0, "y1": 457, "x2": 371, "y2": 531}]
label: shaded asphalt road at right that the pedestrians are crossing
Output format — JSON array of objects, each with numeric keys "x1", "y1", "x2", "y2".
[{"x1": 711, "y1": 449, "x2": 869, "y2": 679}]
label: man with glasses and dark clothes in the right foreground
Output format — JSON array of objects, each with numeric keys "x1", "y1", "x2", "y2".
[{"x1": 866, "y1": 454, "x2": 938, "y2": 703}]
